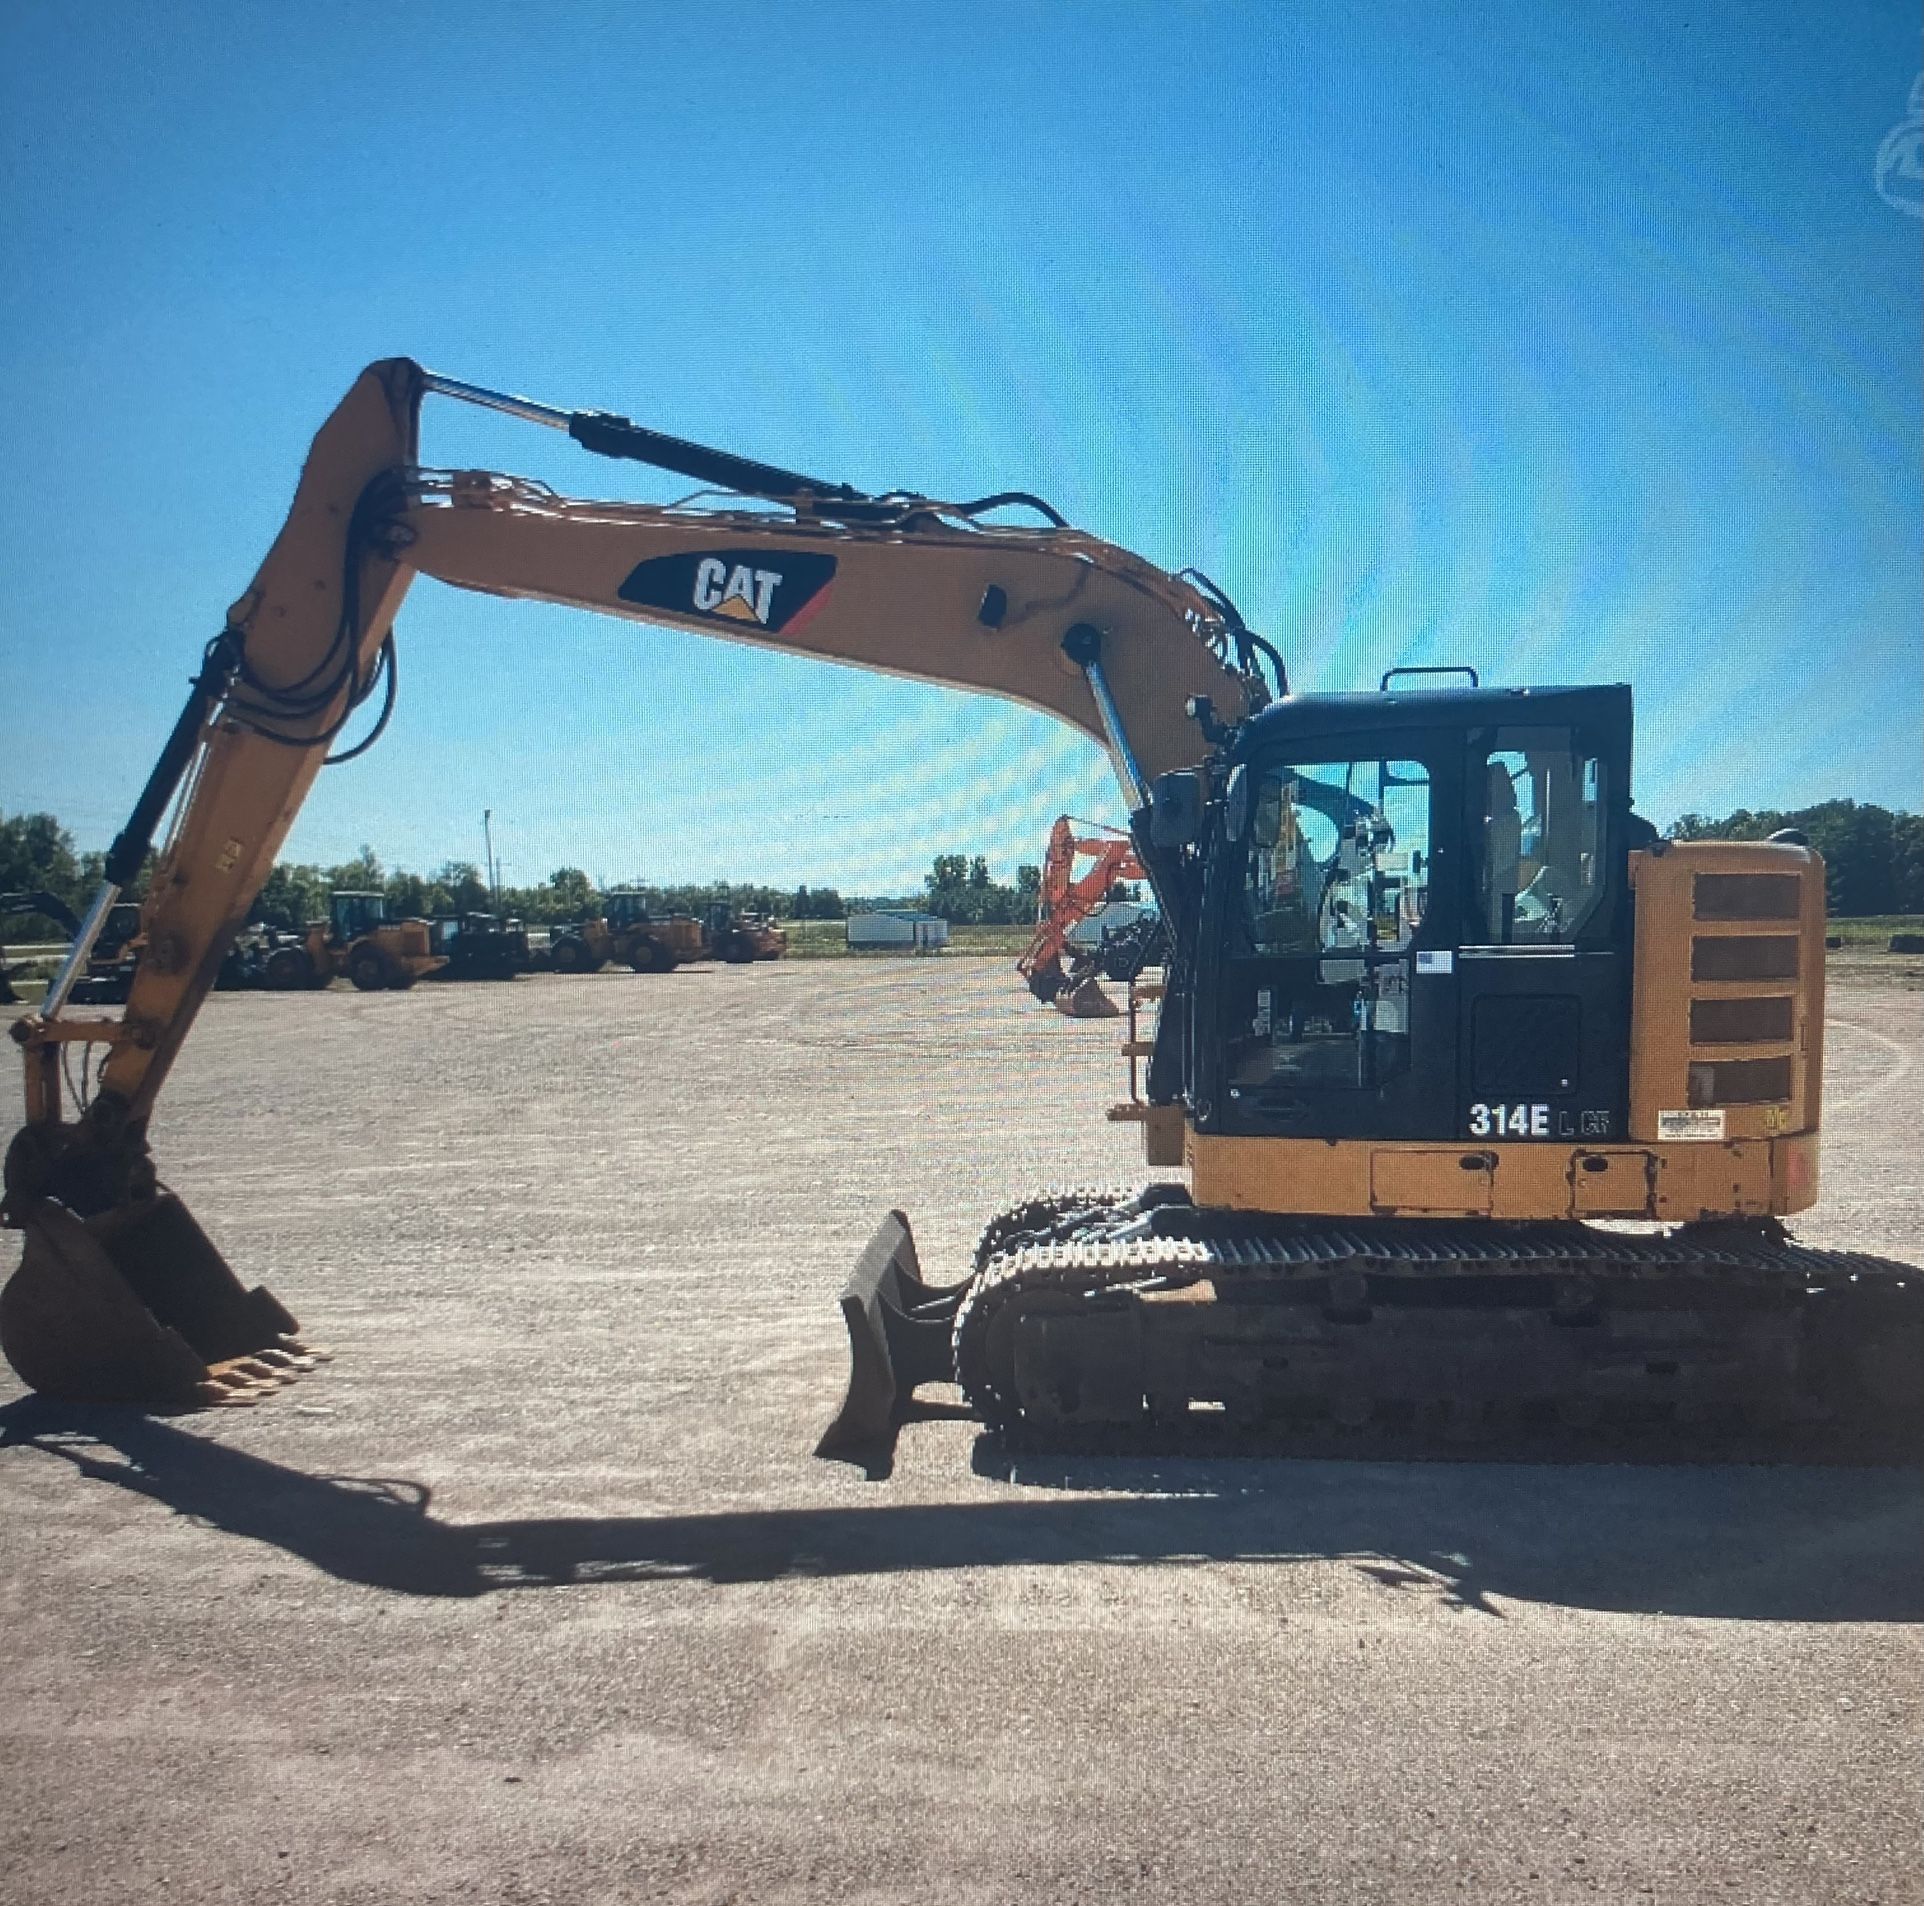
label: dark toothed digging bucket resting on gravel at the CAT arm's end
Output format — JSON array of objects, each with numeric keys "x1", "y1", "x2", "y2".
[{"x1": 0, "y1": 1191, "x2": 312, "y2": 1410}]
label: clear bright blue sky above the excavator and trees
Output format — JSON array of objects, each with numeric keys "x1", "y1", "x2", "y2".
[{"x1": 0, "y1": 0, "x2": 1924, "y2": 892}]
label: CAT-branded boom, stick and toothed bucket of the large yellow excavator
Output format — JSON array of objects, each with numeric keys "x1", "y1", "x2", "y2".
[{"x1": 0, "y1": 360, "x2": 1268, "y2": 1400}]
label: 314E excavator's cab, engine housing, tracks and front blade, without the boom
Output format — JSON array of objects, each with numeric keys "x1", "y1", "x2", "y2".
[{"x1": 823, "y1": 685, "x2": 1924, "y2": 1454}]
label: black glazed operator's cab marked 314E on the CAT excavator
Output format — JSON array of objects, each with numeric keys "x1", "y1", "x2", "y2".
[{"x1": 1187, "y1": 687, "x2": 1632, "y2": 1144}]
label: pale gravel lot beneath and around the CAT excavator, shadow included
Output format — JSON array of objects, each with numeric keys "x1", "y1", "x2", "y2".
[{"x1": 0, "y1": 962, "x2": 1924, "y2": 1906}]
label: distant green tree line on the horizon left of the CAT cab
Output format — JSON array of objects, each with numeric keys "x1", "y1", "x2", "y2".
[{"x1": 0, "y1": 814, "x2": 1041, "y2": 944}]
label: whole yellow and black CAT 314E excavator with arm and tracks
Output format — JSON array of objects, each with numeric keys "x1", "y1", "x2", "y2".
[{"x1": 0, "y1": 360, "x2": 1924, "y2": 1452}]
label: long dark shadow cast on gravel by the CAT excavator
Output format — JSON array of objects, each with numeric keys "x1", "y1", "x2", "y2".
[{"x1": 0, "y1": 1398, "x2": 1924, "y2": 1621}]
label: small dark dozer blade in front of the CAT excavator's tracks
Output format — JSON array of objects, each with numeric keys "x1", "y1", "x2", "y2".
[{"x1": 816, "y1": 1212, "x2": 970, "y2": 1460}]
